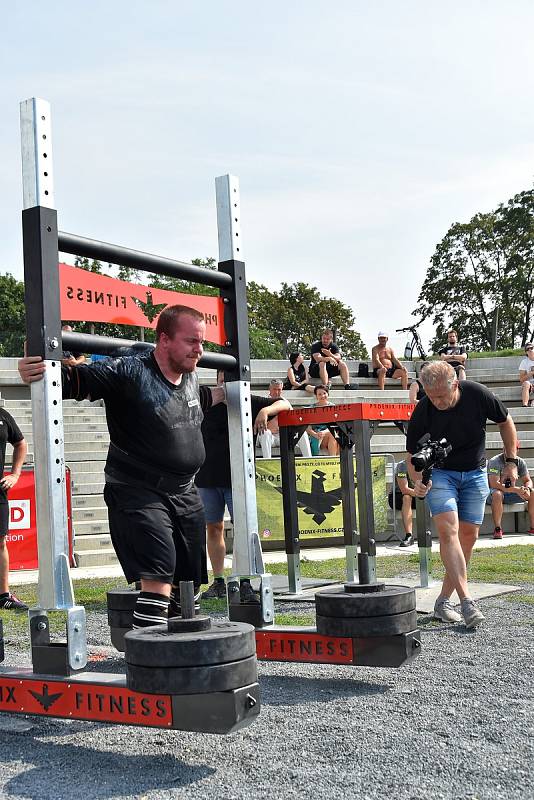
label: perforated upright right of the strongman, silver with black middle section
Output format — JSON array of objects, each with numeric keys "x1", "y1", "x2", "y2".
[{"x1": 215, "y1": 175, "x2": 274, "y2": 624}]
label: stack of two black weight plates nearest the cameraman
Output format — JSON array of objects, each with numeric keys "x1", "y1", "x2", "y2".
[{"x1": 315, "y1": 583, "x2": 417, "y2": 638}]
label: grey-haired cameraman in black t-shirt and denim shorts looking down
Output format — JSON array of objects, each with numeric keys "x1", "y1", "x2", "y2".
[{"x1": 406, "y1": 361, "x2": 517, "y2": 628}]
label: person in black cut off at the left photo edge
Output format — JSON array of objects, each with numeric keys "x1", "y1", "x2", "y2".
[{"x1": 0, "y1": 408, "x2": 28, "y2": 611}]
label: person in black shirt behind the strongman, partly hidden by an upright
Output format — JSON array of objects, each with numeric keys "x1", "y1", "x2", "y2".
[{"x1": 195, "y1": 372, "x2": 291, "y2": 603}]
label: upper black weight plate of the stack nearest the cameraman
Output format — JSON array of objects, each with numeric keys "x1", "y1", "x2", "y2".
[{"x1": 315, "y1": 585, "x2": 415, "y2": 617}]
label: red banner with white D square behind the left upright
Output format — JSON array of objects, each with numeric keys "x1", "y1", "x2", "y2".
[{"x1": 4, "y1": 467, "x2": 73, "y2": 571}]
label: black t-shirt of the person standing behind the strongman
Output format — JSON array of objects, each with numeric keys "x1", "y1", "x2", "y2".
[{"x1": 195, "y1": 394, "x2": 276, "y2": 489}]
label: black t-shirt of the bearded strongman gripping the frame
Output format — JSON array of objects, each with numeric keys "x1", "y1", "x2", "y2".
[{"x1": 63, "y1": 353, "x2": 211, "y2": 484}]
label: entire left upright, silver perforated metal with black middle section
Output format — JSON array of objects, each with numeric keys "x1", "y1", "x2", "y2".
[{"x1": 20, "y1": 98, "x2": 87, "y2": 670}]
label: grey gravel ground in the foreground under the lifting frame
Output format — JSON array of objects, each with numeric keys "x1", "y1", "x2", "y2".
[{"x1": 0, "y1": 585, "x2": 534, "y2": 800}]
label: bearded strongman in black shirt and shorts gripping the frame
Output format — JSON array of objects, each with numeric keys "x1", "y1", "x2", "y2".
[{"x1": 19, "y1": 306, "x2": 224, "y2": 627}]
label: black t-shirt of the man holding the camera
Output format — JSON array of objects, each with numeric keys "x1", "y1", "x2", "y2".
[{"x1": 406, "y1": 381, "x2": 508, "y2": 472}]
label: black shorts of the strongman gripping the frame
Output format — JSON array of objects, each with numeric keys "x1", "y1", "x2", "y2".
[{"x1": 104, "y1": 483, "x2": 208, "y2": 586}]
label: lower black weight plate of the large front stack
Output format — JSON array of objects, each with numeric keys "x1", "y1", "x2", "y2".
[{"x1": 126, "y1": 655, "x2": 257, "y2": 694}]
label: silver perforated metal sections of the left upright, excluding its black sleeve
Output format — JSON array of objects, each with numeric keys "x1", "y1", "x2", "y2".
[{"x1": 20, "y1": 98, "x2": 87, "y2": 669}]
